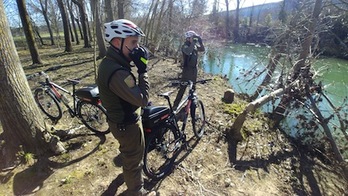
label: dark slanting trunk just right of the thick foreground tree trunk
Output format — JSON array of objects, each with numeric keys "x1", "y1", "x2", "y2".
[{"x1": 16, "y1": 0, "x2": 42, "y2": 64}]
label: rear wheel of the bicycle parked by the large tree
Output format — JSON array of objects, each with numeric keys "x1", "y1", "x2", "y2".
[{"x1": 77, "y1": 101, "x2": 110, "y2": 134}]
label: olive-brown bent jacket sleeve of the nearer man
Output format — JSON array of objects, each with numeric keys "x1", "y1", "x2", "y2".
[{"x1": 109, "y1": 70, "x2": 150, "y2": 107}]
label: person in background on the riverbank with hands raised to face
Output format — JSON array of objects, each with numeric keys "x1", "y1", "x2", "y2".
[{"x1": 173, "y1": 31, "x2": 205, "y2": 110}]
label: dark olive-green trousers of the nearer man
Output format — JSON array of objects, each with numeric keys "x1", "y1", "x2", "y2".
[{"x1": 109, "y1": 120, "x2": 145, "y2": 195}]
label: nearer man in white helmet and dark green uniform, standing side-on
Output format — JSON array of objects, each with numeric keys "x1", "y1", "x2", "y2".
[{"x1": 97, "y1": 19, "x2": 154, "y2": 195}]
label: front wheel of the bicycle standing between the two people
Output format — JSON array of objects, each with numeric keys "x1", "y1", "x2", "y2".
[{"x1": 191, "y1": 100, "x2": 205, "y2": 138}]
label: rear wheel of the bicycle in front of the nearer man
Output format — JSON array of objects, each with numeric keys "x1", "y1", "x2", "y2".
[{"x1": 143, "y1": 124, "x2": 182, "y2": 180}]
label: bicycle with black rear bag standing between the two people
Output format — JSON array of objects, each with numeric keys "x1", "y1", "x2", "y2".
[{"x1": 142, "y1": 79, "x2": 211, "y2": 180}]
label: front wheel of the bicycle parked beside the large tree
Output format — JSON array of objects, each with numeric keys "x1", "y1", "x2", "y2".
[{"x1": 34, "y1": 88, "x2": 63, "y2": 123}]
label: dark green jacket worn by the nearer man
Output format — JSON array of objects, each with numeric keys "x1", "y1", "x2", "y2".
[{"x1": 97, "y1": 46, "x2": 149, "y2": 124}]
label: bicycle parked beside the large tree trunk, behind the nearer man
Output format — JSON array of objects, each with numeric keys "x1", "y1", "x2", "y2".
[{"x1": 34, "y1": 72, "x2": 110, "y2": 134}]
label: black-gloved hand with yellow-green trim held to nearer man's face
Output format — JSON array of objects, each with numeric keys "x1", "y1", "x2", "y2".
[{"x1": 129, "y1": 46, "x2": 148, "y2": 74}]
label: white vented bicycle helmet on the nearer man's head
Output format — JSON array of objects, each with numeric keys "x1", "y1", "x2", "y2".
[{"x1": 104, "y1": 19, "x2": 145, "y2": 42}]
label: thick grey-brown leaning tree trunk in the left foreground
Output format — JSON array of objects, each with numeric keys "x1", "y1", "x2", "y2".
[{"x1": 0, "y1": 1, "x2": 64, "y2": 167}]
